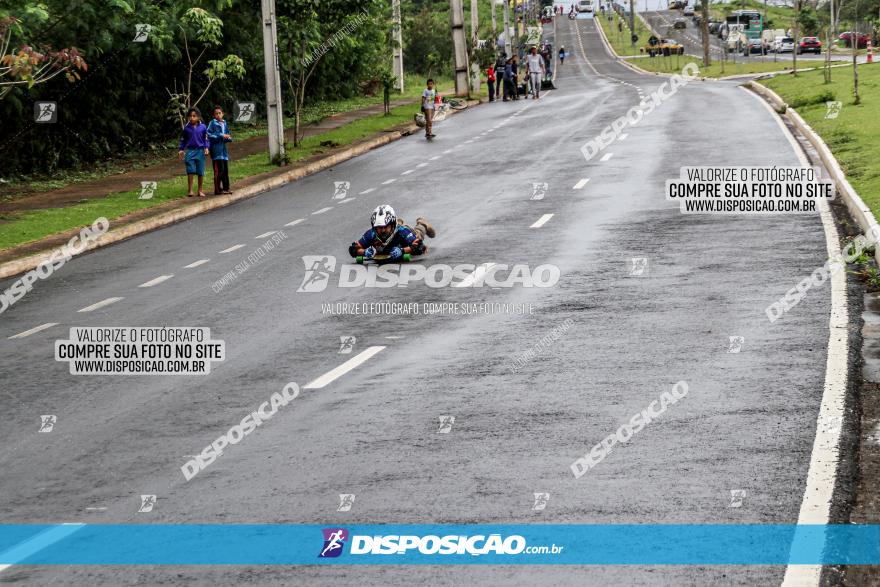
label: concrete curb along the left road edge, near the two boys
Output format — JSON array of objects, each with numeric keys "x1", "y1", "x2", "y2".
[{"x1": 0, "y1": 100, "x2": 481, "y2": 279}]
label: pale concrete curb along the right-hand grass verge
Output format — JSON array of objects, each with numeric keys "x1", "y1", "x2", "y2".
[{"x1": 743, "y1": 81, "x2": 880, "y2": 263}]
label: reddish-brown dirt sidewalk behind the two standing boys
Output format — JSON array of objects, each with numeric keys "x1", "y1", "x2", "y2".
[{"x1": 0, "y1": 98, "x2": 414, "y2": 214}]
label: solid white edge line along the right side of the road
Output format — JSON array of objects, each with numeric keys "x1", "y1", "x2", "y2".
[{"x1": 741, "y1": 88, "x2": 849, "y2": 587}]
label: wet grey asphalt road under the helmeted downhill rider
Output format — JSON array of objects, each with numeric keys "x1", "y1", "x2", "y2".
[{"x1": 0, "y1": 13, "x2": 844, "y2": 585}]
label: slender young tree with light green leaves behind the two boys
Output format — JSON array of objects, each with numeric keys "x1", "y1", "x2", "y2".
[{"x1": 166, "y1": 8, "x2": 245, "y2": 127}]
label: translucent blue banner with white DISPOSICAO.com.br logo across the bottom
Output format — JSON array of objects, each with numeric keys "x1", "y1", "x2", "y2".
[{"x1": 0, "y1": 524, "x2": 880, "y2": 565}]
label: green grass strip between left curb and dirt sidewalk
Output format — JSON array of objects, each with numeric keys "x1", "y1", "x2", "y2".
[{"x1": 0, "y1": 104, "x2": 430, "y2": 249}]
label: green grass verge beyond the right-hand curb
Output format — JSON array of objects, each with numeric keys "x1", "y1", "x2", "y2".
[{"x1": 761, "y1": 64, "x2": 880, "y2": 217}]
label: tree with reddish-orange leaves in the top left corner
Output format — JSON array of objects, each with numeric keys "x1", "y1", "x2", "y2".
[{"x1": 0, "y1": 14, "x2": 88, "y2": 100}]
